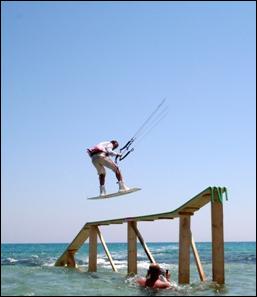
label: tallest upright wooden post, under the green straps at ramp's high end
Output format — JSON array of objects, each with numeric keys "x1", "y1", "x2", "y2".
[{"x1": 211, "y1": 192, "x2": 225, "y2": 285}]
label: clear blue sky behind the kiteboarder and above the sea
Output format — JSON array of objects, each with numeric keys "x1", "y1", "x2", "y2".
[{"x1": 1, "y1": 1, "x2": 256, "y2": 242}]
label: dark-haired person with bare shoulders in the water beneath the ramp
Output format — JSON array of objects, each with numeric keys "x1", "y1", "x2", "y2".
[{"x1": 137, "y1": 263, "x2": 171, "y2": 289}]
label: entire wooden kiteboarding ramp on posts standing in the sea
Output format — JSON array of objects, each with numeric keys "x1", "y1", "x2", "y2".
[{"x1": 55, "y1": 187, "x2": 227, "y2": 284}]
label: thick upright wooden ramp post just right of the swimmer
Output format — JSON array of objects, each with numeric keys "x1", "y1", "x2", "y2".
[{"x1": 178, "y1": 214, "x2": 191, "y2": 284}]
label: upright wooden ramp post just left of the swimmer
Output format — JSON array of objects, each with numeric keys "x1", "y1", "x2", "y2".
[{"x1": 128, "y1": 221, "x2": 137, "y2": 274}]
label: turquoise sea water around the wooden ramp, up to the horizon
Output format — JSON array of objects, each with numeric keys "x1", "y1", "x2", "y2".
[{"x1": 1, "y1": 242, "x2": 256, "y2": 296}]
